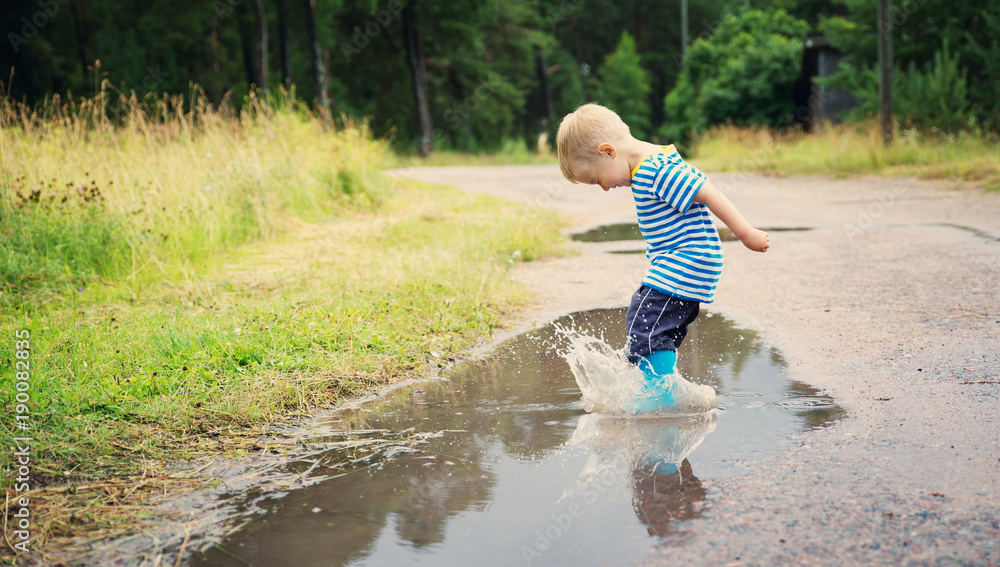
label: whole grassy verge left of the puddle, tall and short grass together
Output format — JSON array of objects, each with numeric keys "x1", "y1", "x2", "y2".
[{"x1": 0, "y1": 90, "x2": 560, "y2": 560}]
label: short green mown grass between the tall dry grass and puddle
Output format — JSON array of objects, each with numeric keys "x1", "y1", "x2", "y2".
[{"x1": 0, "y1": 183, "x2": 558, "y2": 479}]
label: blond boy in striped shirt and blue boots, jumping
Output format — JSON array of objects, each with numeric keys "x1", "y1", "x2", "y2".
[{"x1": 556, "y1": 104, "x2": 770, "y2": 410}]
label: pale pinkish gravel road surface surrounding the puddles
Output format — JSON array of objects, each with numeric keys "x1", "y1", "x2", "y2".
[{"x1": 398, "y1": 165, "x2": 1000, "y2": 565}]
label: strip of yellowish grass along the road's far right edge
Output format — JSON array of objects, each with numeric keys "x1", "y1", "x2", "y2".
[{"x1": 691, "y1": 124, "x2": 1000, "y2": 191}]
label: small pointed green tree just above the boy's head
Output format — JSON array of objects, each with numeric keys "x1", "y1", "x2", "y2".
[{"x1": 597, "y1": 32, "x2": 652, "y2": 139}]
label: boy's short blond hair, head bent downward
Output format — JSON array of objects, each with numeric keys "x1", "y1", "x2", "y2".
[{"x1": 556, "y1": 104, "x2": 631, "y2": 183}]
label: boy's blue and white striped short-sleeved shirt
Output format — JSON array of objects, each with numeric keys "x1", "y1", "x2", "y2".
[{"x1": 632, "y1": 146, "x2": 722, "y2": 303}]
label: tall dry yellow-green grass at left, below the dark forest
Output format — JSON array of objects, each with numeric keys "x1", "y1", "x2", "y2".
[{"x1": 0, "y1": 83, "x2": 388, "y2": 305}]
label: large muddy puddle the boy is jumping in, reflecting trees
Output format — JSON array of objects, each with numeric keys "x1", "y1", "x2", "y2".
[{"x1": 188, "y1": 309, "x2": 844, "y2": 567}]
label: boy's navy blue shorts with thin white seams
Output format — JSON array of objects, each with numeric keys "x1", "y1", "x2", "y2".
[{"x1": 625, "y1": 286, "x2": 701, "y2": 362}]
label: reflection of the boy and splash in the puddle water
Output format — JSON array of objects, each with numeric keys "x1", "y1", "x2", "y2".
[{"x1": 571, "y1": 412, "x2": 717, "y2": 537}]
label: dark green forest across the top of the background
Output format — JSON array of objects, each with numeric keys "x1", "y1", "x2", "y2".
[{"x1": 7, "y1": 0, "x2": 1000, "y2": 154}]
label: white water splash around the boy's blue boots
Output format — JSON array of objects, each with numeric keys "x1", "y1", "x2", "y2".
[{"x1": 555, "y1": 325, "x2": 718, "y2": 415}]
